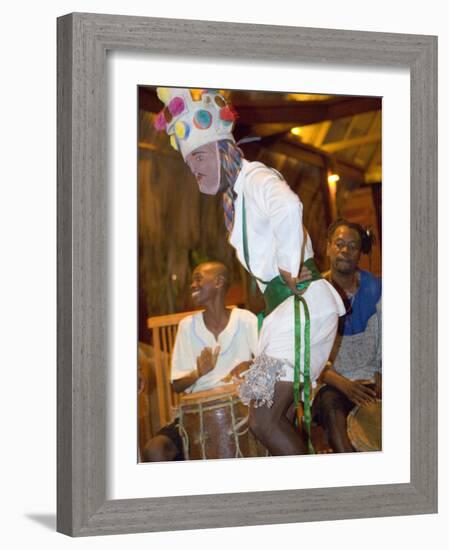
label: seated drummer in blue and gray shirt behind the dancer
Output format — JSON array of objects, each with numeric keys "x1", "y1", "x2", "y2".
[{"x1": 313, "y1": 219, "x2": 382, "y2": 453}]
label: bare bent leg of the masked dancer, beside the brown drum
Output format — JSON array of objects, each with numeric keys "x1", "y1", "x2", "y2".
[{"x1": 249, "y1": 382, "x2": 307, "y2": 456}]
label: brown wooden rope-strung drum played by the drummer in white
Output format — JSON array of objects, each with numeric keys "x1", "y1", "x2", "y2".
[{"x1": 178, "y1": 384, "x2": 267, "y2": 460}]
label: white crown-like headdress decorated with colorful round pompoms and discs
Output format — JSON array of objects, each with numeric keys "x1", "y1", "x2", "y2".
[{"x1": 154, "y1": 88, "x2": 236, "y2": 159}]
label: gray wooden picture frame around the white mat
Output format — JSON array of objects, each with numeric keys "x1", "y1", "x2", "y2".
[{"x1": 57, "y1": 13, "x2": 437, "y2": 536}]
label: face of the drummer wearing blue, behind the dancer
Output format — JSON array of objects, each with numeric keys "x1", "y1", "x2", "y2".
[{"x1": 327, "y1": 225, "x2": 362, "y2": 274}]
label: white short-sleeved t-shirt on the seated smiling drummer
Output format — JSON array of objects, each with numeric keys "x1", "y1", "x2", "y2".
[{"x1": 171, "y1": 308, "x2": 257, "y2": 393}]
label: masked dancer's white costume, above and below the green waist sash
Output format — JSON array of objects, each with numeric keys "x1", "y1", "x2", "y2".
[{"x1": 229, "y1": 160, "x2": 346, "y2": 381}]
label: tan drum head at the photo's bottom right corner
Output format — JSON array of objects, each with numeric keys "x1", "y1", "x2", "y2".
[{"x1": 348, "y1": 399, "x2": 382, "y2": 452}]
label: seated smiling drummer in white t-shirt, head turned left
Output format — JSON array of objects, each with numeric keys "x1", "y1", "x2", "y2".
[{"x1": 143, "y1": 262, "x2": 257, "y2": 462}]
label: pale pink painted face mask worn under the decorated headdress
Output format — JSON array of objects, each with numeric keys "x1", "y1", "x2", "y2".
[{"x1": 185, "y1": 141, "x2": 221, "y2": 195}]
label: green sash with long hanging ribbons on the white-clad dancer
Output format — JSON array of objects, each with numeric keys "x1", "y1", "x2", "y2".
[{"x1": 242, "y1": 196, "x2": 321, "y2": 454}]
